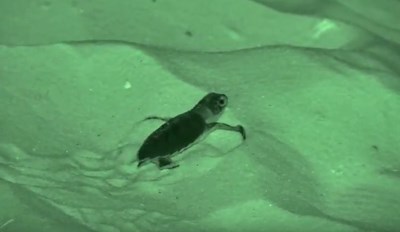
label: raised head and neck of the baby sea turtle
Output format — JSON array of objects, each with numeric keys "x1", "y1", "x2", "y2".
[{"x1": 192, "y1": 92, "x2": 228, "y2": 123}]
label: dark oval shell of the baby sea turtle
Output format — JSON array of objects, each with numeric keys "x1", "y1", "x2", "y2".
[{"x1": 137, "y1": 111, "x2": 206, "y2": 166}]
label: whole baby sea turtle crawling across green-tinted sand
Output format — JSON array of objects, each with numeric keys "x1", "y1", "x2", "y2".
[{"x1": 137, "y1": 92, "x2": 246, "y2": 169}]
